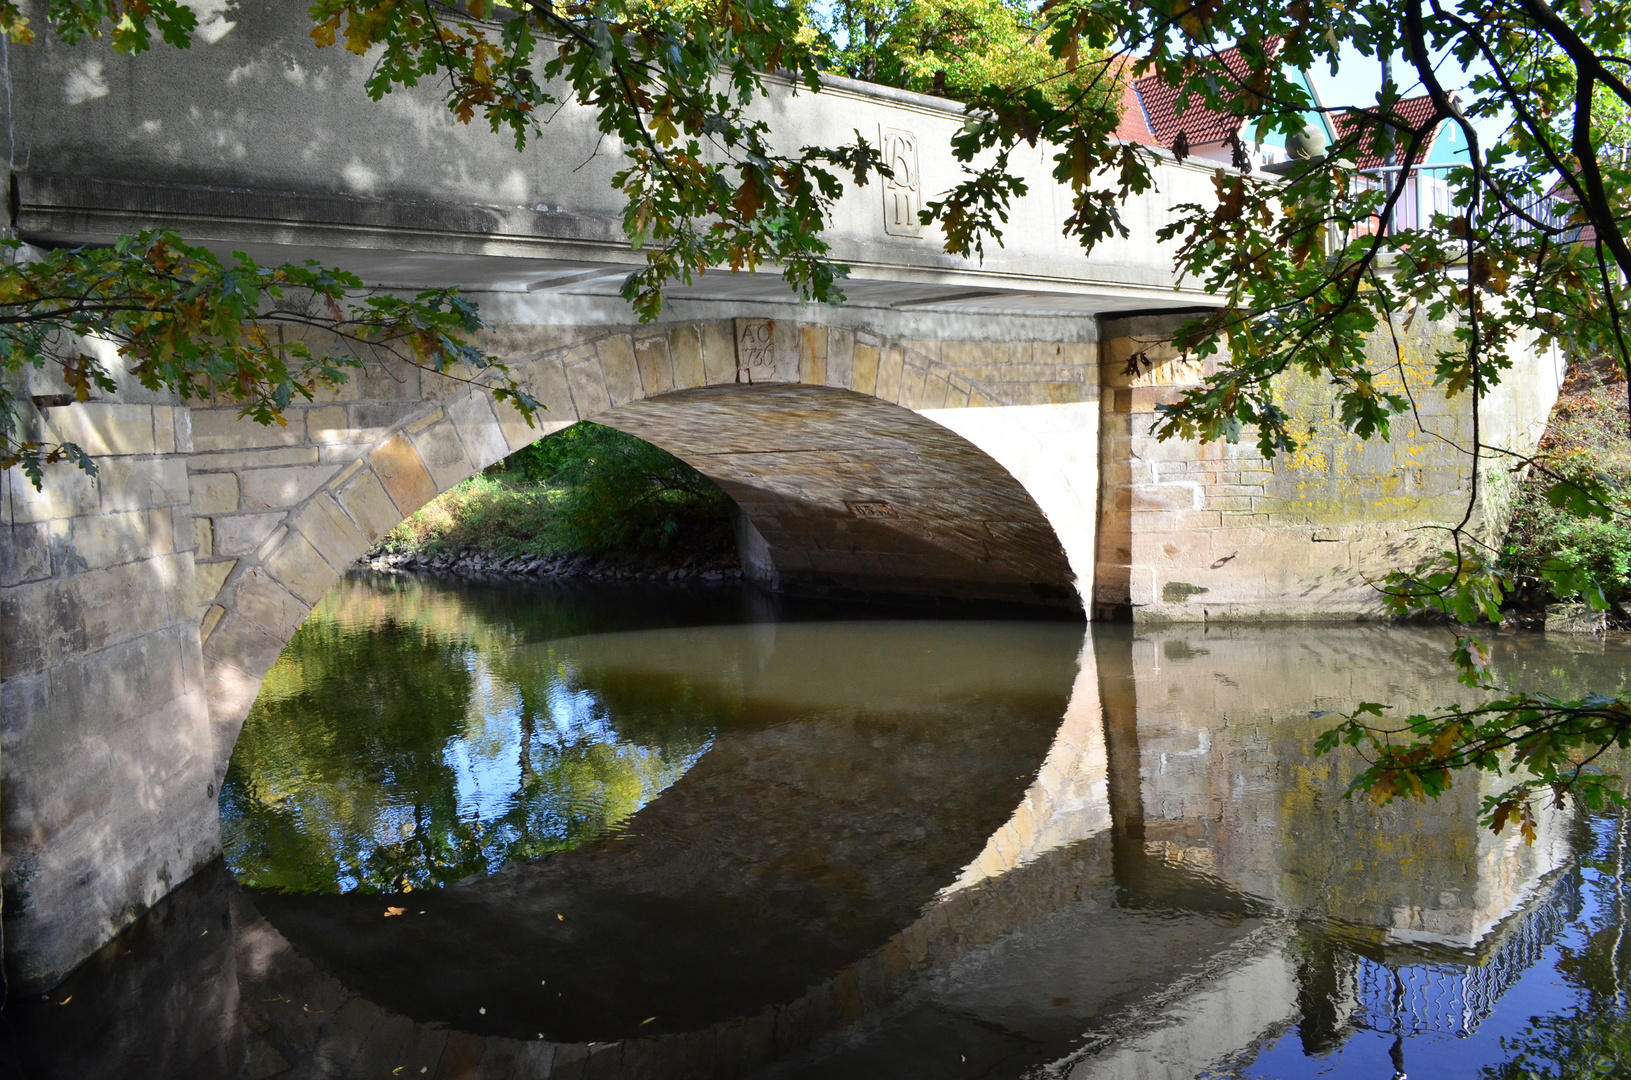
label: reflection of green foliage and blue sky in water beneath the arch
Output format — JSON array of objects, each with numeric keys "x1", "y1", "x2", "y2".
[{"x1": 222, "y1": 591, "x2": 711, "y2": 892}]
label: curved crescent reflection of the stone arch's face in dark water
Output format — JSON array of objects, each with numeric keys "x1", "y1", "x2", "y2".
[{"x1": 223, "y1": 629, "x2": 1128, "y2": 1077}]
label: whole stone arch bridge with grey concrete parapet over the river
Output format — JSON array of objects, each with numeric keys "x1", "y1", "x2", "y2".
[{"x1": 0, "y1": 0, "x2": 1559, "y2": 989}]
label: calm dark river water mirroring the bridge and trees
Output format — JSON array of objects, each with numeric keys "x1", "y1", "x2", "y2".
[{"x1": 9, "y1": 576, "x2": 1631, "y2": 1080}]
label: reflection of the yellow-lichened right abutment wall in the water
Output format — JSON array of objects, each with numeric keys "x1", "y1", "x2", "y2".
[{"x1": 1099, "y1": 628, "x2": 1567, "y2": 946}]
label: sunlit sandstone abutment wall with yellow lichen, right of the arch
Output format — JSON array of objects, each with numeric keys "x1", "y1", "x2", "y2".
[{"x1": 1094, "y1": 316, "x2": 1559, "y2": 622}]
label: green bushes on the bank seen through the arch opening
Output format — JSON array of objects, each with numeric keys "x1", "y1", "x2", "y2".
[{"x1": 380, "y1": 423, "x2": 732, "y2": 555}]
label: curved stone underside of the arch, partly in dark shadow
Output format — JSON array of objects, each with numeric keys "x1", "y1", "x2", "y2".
[{"x1": 597, "y1": 385, "x2": 1081, "y2": 610}]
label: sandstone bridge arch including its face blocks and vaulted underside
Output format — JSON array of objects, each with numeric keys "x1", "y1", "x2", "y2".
[{"x1": 188, "y1": 318, "x2": 1098, "y2": 785}]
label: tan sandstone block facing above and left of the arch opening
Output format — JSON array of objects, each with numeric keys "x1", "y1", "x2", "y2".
[{"x1": 188, "y1": 318, "x2": 1098, "y2": 792}]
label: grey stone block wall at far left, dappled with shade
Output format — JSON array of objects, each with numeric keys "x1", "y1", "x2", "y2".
[{"x1": 0, "y1": 401, "x2": 220, "y2": 992}]
